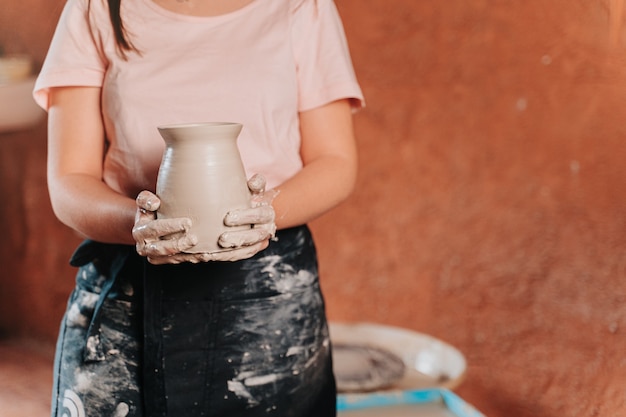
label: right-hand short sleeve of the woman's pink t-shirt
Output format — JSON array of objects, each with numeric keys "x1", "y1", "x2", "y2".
[{"x1": 292, "y1": 0, "x2": 365, "y2": 111}]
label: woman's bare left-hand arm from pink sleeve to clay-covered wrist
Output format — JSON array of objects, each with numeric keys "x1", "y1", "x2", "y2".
[{"x1": 48, "y1": 87, "x2": 137, "y2": 244}]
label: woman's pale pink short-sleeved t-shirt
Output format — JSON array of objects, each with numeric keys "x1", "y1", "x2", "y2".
[{"x1": 34, "y1": 0, "x2": 363, "y2": 197}]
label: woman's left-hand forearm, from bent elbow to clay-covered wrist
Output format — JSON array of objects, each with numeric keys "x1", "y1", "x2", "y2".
[{"x1": 48, "y1": 174, "x2": 137, "y2": 244}]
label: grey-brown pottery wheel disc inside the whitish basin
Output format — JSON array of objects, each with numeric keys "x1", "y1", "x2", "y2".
[{"x1": 333, "y1": 343, "x2": 405, "y2": 392}]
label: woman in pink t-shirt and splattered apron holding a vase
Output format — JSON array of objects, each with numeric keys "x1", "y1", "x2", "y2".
[{"x1": 35, "y1": 0, "x2": 362, "y2": 417}]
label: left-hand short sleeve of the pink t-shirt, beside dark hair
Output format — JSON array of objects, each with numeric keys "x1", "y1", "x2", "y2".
[{"x1": 33, "y1": 0, "x2": 105, "y2": 110}]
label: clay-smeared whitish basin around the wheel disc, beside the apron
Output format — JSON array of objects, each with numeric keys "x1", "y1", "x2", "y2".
[{"x1": 330, "y1": 322, "x2": 467, "y2": 391}]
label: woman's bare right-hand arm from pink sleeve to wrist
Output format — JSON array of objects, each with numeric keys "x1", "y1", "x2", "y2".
[{"x1": 272, "y1": 99, "x2": 357, "y2": 229}]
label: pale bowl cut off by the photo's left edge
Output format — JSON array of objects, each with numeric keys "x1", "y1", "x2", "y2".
[{"x1": 0, "y1": 77, "x2": 45, "y2": 132}]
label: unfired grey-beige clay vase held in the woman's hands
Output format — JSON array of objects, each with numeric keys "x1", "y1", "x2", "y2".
[{"x1": 156, "y1": 123, "x2": 250, "y2": 253}]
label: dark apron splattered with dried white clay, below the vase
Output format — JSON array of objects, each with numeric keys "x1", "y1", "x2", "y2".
[{"x1": 52, "y1": 227, "x2": 336, "y2": 417}]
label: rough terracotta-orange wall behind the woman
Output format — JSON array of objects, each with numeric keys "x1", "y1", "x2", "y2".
[{"x1": 0, "y1": 0, "x2": 626, "y2": 417}]
